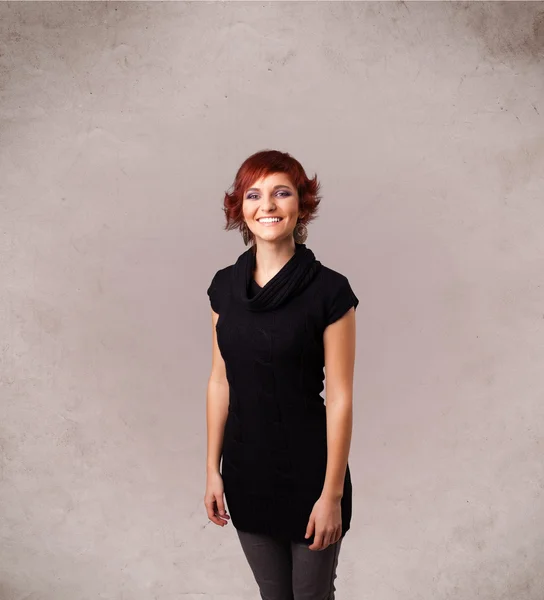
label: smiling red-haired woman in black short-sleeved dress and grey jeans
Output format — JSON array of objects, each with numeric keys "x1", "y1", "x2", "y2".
[{"x1": 204, "y1": 150, "x2": 359, "y2": 600}]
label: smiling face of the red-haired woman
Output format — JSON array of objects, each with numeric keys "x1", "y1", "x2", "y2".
[{"x1": 242, "y1": 173, "x2": 299, "y2": 242}]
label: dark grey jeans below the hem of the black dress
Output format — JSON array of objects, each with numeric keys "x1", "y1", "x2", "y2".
[{"x1": 236, "y1": 529, "x2": 342, "y2": 600}]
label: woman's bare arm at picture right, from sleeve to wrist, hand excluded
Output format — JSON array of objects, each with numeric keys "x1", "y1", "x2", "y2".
[{"x1": 322, "y1": 308, "x2": 355, "y2": 500}]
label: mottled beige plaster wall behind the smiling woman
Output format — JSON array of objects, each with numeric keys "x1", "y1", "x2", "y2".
[{"x1": 0, "y1": 2, "x2": 544, "y2": 600}]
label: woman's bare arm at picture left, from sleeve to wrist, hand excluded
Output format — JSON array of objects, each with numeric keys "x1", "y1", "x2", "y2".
[{"x1": 206, "y1": 310, "x2": 229, "y2": 474}]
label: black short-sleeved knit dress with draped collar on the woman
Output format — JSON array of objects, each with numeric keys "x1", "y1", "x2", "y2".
[{"x1": 207, "y1": 244, "x2": 359, "y2": 544}]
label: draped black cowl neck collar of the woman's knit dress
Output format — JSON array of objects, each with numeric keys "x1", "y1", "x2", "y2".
[{"x1": 233, "y1": 242, "x2": 321, "y2": 311}]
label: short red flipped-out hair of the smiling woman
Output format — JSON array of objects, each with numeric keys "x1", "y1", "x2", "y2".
[{"x1": 223, "y1": 150, "x2": 321, "y2": 240}]
